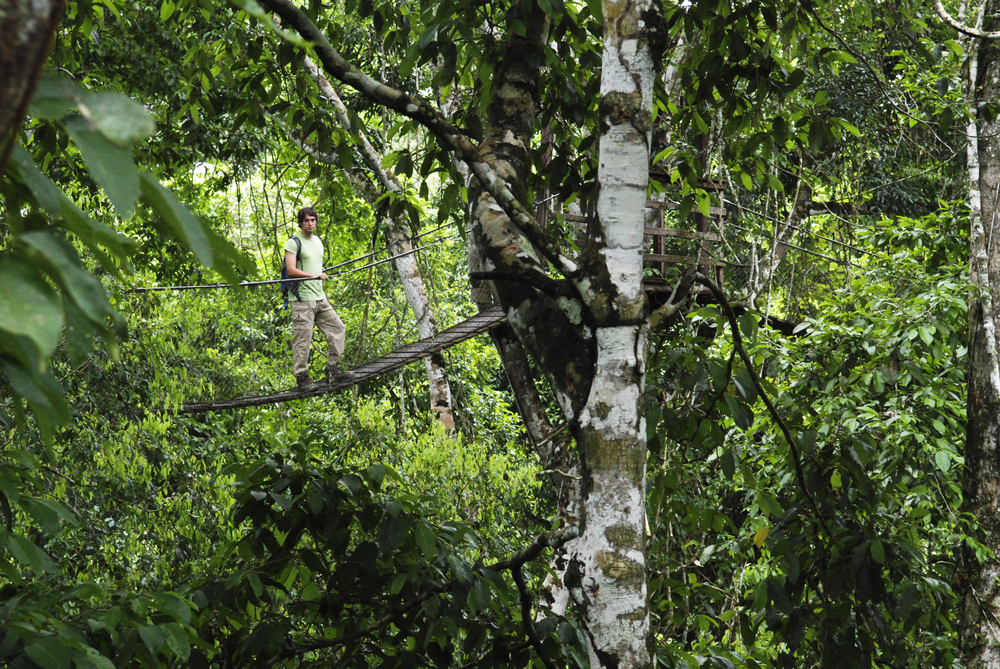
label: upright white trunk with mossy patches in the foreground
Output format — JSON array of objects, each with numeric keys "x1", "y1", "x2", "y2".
[{"x1": 566, "y1": 0, "x2": 662, "y2": 667}]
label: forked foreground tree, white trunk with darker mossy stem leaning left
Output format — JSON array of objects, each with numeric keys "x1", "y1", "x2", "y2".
[{"x1": 462, "y1": 0, "x2": 662, "y2": 667}]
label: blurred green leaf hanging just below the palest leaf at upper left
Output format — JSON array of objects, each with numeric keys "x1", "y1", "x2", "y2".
[{"x1": 66, "y1": 119, "x2": 139, "y2": 220}]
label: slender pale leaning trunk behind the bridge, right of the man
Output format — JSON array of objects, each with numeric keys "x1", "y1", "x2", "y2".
[{"x1": 305, "y1": 57, "x2": 455, "y2": 431}]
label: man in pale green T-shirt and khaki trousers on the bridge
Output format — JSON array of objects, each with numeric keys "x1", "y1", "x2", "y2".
[{"x1": 285, "y1": 207, "x2": 355, "y2": 391}]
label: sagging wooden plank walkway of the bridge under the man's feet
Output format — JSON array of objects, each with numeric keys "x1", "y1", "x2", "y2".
[{"x1": 171, "y1": 307, "x2": 507, "y2": 413}]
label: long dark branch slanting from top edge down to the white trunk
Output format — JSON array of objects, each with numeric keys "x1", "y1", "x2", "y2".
[{"x1": 254, "y1": 0, "x2": 576, "y2": 274}]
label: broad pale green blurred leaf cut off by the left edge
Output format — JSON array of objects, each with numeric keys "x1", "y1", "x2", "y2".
[{"x1": 0, "y1": 255, "x2": 63, "y2": 357}]
